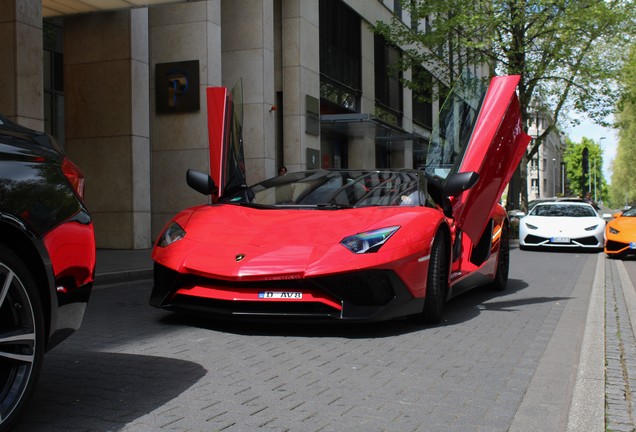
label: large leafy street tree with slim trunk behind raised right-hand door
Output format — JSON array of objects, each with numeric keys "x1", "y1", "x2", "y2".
[{"x1": 376, "y1": 0, "x2": 636, "y2": 209}]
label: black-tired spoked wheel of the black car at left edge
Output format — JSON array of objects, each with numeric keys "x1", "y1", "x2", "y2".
[{"x1": 0, "y1": 246, "x2": 44, "y2": 431}]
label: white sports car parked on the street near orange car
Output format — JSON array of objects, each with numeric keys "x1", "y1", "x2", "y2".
[{"x1": 519, "y1": 201, "x2": 605, "y2": 249}]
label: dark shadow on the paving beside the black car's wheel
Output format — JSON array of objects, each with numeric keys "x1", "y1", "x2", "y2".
[{"x1": 14, "y1": 350, "x2": 207, "y2": 432}]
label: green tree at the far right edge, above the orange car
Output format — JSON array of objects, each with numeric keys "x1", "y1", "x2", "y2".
[{"x1": 610, "y1": 45, "x2": 636, "y2": 207}]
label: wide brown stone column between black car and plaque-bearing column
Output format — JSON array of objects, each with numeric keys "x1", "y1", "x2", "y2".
[{"x1": 65, "y1": 8, "x2": 151, "y2": 249}]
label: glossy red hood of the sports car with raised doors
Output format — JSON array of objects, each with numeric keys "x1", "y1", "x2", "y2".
[{"x1": 153, "y1": 204, "x2": 440, "y2": 279}]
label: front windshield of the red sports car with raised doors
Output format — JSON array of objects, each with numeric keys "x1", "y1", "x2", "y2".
[{"x1": 219, "y1": 170, "x2": 426, "y2": 209}]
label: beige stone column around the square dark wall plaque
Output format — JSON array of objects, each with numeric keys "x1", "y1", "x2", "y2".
[{"x1": 150, "y1": 0, "x2": 222, "y2": 238}]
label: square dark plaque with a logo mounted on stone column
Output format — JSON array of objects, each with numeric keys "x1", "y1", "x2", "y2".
[{"x1": 155, "y1": 60, "x2": 200, "y2": 113}]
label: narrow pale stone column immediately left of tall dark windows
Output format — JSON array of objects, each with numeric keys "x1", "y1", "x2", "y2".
[{"x1": 282, "y1": 0, "x2": 320, "y2": 171}]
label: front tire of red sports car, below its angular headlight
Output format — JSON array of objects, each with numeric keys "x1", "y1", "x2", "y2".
[{"x1": 422, "y1": 233, "x2": 448, "y2": 324}]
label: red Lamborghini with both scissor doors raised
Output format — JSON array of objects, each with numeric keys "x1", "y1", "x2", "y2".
[{"x1": 150, "y1": 76, "x2": 529, "y2": 322}]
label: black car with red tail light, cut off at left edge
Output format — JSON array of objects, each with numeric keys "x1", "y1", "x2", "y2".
[{"x1": 0, "y1": 116, "x2": 95, "y2": 431}]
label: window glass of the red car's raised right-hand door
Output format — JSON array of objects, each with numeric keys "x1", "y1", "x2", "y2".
[{"x1": 426, "y1": 79, "x2": 488, "y2": 179}]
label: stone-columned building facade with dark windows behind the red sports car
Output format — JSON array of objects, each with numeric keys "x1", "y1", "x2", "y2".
[{"x1": 0, "y1": 0, "x2": 488, "y2": 249}]
